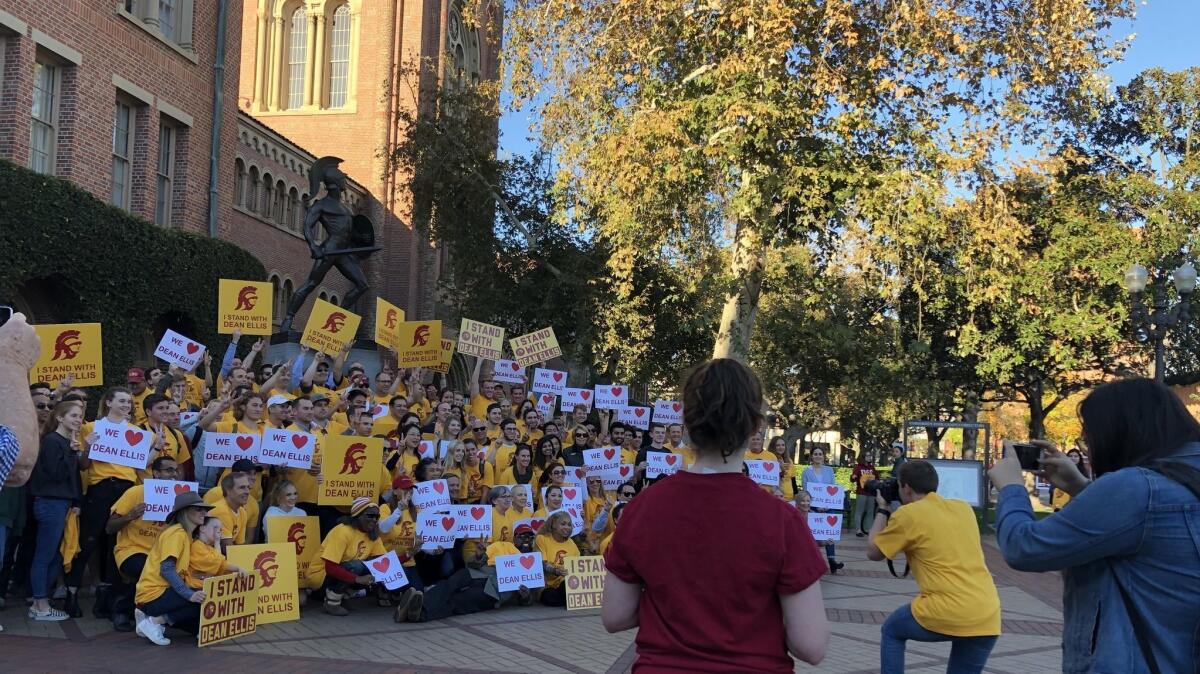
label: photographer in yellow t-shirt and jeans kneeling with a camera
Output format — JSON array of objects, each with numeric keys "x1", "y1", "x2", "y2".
[{"x1": 866, "y1": 461, "x2": 1000, "y2": 674}]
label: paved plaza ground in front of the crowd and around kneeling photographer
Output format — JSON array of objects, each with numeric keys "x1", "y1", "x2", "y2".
[{"x1": 0, "y1": 536, "x2": 1062, "y2": 674}]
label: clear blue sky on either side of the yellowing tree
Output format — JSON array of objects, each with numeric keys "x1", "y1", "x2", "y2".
[{"x1": 500, "y1": 0, "x2": 1200, "y2": 154}]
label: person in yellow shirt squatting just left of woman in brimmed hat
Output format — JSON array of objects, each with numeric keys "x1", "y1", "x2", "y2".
[{"x1": 104, "y1": 456, "x2": 179, "y2": 632}]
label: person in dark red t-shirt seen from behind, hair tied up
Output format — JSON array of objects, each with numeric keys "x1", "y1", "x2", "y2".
[{"x1": 601, "y1": 359, "x2": 829, "y2": 674}]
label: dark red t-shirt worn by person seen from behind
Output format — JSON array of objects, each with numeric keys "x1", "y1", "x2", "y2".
[{"x1": 605, "y1": 473, "x2": 829, "y2": 673}]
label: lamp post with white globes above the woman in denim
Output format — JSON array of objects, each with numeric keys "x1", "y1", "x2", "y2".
[{"x1": 1124, "y1": 263, "x2": 1196, "y2": 381}]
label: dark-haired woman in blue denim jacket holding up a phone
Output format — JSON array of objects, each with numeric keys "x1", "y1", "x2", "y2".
[{"x1": 989, "y1": 379, "x2": 1200, "y2": 674}]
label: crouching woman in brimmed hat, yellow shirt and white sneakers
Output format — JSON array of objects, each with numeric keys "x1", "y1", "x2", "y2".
[{"x1": 134, "y1": 491, "x2": 212, "y2": 646}]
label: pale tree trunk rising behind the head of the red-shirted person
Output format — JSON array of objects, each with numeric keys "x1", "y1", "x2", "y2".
[{"x1": 713, "y1": 221, "x2": 767, "y2": 361}]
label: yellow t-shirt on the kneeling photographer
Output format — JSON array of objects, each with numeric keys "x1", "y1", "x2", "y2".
[{"x1": 875, "y1": 493, "x2": 1000, "y2": 637}]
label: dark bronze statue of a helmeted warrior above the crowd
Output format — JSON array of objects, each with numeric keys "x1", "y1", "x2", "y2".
[{"x1": 280, "y1": 157, "x2": 379, "y2": 335}]
